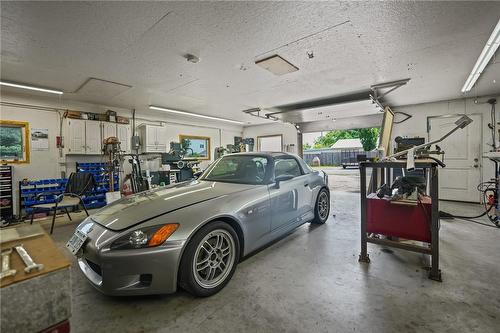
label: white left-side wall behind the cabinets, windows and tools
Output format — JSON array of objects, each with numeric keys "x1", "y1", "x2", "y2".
[{"x1": 0, "y1": 93, "x2": 243, "y2": 214}]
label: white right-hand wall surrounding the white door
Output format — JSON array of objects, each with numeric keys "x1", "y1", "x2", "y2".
[{"x1": 392, "y1": 96, "x2": 500, "y2": 186}]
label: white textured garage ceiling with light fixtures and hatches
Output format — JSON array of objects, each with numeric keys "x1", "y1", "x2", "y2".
[{"x1": 1, "y1": 1, "x2": 500, "y2": 123}]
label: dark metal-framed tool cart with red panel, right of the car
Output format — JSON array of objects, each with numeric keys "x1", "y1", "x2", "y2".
[{"x1": 359, "y1": 160, "x2": 441, "y2": 281}]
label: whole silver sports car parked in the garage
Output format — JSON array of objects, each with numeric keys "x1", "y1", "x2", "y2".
[{"x1": 67, "y1": 153, "x2": 330, "y2": 296}]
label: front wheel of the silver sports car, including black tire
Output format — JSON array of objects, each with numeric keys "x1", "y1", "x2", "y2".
[{"x1": 179, "y1": 221, "x2": 240, "y2": 297}]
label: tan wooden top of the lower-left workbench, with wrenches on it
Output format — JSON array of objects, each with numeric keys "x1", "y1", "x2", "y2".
[{"x1": 0, "y1": 227, "x2": 70, "y2": 288}]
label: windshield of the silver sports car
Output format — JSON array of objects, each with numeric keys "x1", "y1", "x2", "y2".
[{"x1": 201, "y1": 155, "x2": 267, "y2": 185}]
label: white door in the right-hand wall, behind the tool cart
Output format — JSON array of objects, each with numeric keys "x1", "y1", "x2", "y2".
[{"x1": 428, "y1": 115, "x2": 482, "y2": 202}]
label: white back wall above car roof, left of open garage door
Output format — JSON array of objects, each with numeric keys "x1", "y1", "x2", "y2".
[{"x1": 243, "y1": 122, "x2": 297, "y2": 154}]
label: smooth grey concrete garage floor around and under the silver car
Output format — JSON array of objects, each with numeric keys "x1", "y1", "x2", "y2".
[{"x1": 37, "y1": 169, "x2": 500, "y2": 333}]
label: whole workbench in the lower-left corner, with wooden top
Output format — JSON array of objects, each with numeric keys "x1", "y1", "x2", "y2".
[{"x1": 0, "y1": 224, "x2": 71, "y2": 333}]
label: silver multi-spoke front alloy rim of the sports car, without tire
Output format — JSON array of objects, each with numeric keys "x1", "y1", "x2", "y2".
[{"x1": 193, "y1": 229, "x2": 235, "y2": 289}]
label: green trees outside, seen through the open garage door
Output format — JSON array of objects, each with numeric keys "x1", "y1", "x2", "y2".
[{"x1": 304, "y1": 127, "x2": 380, "y2": 151}]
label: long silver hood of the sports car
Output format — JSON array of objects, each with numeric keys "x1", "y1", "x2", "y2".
[{"x1": 91, "y1": 180, "x2": 252, "y2": 231}]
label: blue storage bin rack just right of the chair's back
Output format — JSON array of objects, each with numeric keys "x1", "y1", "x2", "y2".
[{"x1": 76, "y1": 162, "x2": 120, "y2": 208}]
